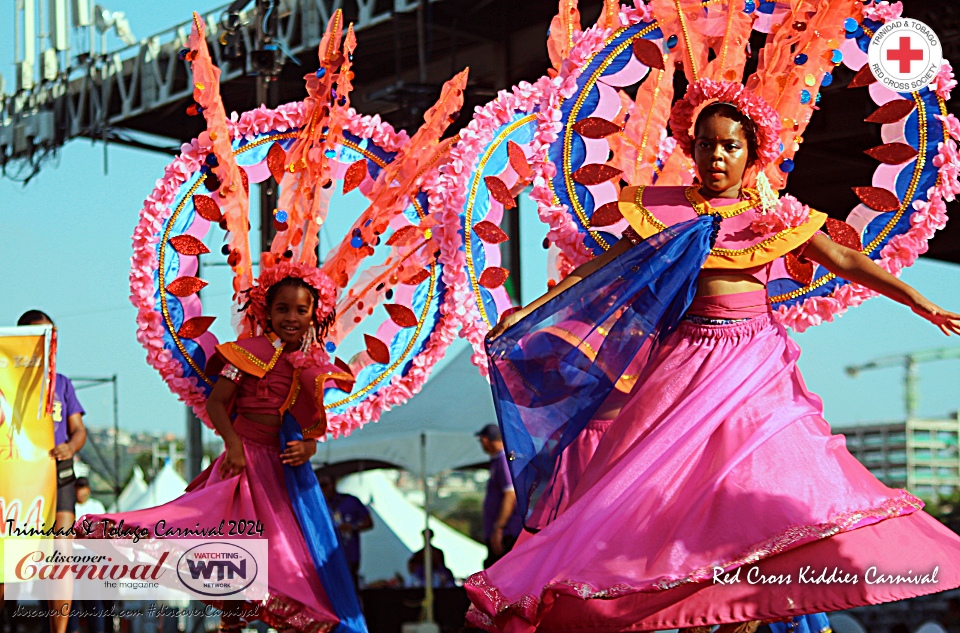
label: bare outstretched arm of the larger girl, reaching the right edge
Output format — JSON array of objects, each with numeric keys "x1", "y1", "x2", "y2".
[{"x1": 803, "y1": 233, "x2": 960, "y2": 336}]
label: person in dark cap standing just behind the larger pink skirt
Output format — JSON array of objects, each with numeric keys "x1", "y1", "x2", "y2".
[{"x1": 477, "y1": 424, "x2": 523, "y2": 569}]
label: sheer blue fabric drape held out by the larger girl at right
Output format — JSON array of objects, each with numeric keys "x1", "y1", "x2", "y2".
[{"x1": 487, "y1": 216, "x2": 716, "y2": 530}]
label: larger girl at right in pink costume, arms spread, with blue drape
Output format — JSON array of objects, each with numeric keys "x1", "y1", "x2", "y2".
[{"x1": 466, "y1": 80, "x2": 960, "y2": 633}]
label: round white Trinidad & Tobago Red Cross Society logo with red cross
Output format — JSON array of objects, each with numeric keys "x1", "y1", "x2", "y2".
[{"x1": 867, "y1": 18, "x2": 943, "y2": 92}]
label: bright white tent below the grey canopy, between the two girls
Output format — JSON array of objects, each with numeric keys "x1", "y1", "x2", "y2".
[{"x1": 338, "y1": 470, "x2": 487, "y2": 583}]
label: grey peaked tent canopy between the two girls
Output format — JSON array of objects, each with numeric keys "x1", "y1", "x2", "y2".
[{"x1": 313, "y1": 339, "x2": 497, "y2": 475}]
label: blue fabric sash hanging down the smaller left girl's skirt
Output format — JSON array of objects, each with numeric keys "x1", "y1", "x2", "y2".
[{"x1": 280, "y1": 413, "x2": 367, "y2": 633}]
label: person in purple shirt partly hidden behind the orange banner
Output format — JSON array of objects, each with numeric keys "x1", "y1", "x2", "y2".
[{"x1": 17, "y1": 310, "x2": 87, "y2": 633}]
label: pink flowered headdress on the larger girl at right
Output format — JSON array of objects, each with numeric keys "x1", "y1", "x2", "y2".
[{"x1": 670, "y1": 79, "x2": 781, "y2": 168}]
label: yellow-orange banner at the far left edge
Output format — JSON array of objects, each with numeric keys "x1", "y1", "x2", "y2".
[{"x1": 0, "y1": 326, "x2": 57, "y2": 582}]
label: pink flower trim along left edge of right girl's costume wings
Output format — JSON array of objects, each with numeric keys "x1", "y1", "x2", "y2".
[{"x1": 438, "y1": 77, "x2": 549, "y2": 375}]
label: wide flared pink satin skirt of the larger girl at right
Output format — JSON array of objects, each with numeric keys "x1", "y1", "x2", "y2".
[{"x1": 467, "y1": 314, "x2": 960, "y2": 633}]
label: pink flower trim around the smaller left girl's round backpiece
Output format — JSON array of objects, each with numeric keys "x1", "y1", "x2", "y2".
[{"x1": 130, "y1": 108, "x2": 457, "y2": 437}]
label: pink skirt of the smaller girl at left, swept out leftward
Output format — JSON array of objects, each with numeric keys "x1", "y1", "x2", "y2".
[{"x1": 78, "y1": 416, "x2": 339, "y2": 633}]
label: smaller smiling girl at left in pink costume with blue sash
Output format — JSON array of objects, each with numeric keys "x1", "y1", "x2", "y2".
[{"x1": 78, "y1": 262, "x2": 366, "y2": 633}]
